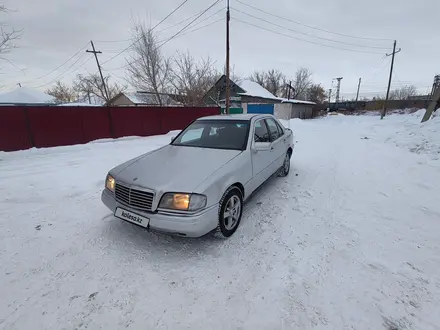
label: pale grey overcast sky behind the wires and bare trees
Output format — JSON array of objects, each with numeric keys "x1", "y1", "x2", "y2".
[{"x1": 0, "y1": 0, "x2": 440, "y2": 98}]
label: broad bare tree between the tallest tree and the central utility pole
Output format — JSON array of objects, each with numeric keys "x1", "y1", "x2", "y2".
[{"x1": 171, "y1": 52, "x2": 219, "y2": 106}]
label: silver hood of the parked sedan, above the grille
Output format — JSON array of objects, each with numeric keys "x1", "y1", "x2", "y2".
[{"x1": 111, "y1": 145, "x2": 242, "y2": 194}]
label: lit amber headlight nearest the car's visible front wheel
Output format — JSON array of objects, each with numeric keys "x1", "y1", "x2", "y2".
[{"x1": 159, "y1": 193, "x2": 206, "y2": 211}]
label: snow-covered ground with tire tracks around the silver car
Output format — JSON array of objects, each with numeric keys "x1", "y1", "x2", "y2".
[{"x1": 0, "y1": 113, "x2": 440, "y2": 330}]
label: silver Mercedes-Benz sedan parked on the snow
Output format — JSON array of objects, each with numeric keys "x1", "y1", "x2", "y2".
[{"x1": 101, "y1": 114, "x2": 294, "y2": 237}]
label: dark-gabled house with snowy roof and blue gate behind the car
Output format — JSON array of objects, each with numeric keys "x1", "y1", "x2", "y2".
[{"x1": 203, "y1": 75, "x2": 316, "y2": 119}]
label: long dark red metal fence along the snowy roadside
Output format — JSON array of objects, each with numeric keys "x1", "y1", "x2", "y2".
[{"x1": 0, "y1": 106, "x2": 220, "y2": 151}]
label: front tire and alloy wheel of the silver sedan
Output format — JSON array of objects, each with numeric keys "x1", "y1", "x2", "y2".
[{"x1": 217, "y1": 186, "x2": 243, "y2": 238}]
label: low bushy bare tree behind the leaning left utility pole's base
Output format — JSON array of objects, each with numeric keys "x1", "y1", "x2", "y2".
[{"x1": 73, "y1": 73, "x2": 127, "y2": 103}]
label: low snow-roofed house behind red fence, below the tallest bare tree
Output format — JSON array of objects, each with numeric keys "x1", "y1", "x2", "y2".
[{"x1": 108, "y1": 92, "x2": 182, "y2": 107}]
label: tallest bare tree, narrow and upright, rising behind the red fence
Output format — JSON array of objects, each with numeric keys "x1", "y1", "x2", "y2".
[{"x1": 127, "y1": 24, "x2": 171, "y2": 105}]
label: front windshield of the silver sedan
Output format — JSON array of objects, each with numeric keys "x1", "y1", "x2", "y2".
[{"x1": 172, "y1": 120, "x2": 249, "y2": 150}]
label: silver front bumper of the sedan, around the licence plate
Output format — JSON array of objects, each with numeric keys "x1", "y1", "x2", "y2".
[{"x1": 101, "y1": 189, "x2": 218, "y2": 237}]
